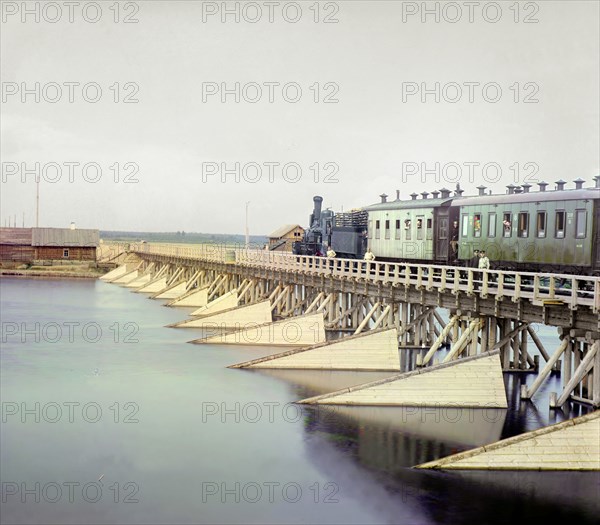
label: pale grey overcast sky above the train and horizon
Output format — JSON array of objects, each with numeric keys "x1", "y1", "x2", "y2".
[{"x1": 0, "y1": 1, "x2": 600, "y2": 234}]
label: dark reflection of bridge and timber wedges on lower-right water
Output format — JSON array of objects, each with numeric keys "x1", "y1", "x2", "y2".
[{"x1": 259, "y1": 370, "x2": 600, "y2": 524}]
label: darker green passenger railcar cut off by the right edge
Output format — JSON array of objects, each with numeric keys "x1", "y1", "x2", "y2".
[{"x1": 454, "y1": 189, "x2": 600, "y2": 271}]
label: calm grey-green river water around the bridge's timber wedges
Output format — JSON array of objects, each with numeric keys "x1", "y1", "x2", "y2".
[{"x1": 0, "y1": 278, "x2": 600, "y2": 525}]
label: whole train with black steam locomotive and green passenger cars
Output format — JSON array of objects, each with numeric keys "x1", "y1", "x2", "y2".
[{"x1": 293, "y1": 175, "x2": 600, "y2": 276}]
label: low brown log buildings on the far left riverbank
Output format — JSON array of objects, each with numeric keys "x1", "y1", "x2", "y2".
[{"x1": 0, "y1": 227, "x2": 100, "y2": 264}]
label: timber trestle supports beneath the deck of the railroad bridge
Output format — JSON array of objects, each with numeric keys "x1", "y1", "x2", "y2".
[{"x1": 105, "y1": 254, "x2": 600, "y2": 407}]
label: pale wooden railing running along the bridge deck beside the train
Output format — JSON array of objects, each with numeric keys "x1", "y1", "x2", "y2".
[{"x1": 130, "y1": 243, "x2": 600, "y2": 313}]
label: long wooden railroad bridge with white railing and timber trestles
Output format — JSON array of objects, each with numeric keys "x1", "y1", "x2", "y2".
[{"x1": 99, "y1": 243, "x2": 600, "y2": 407}]
